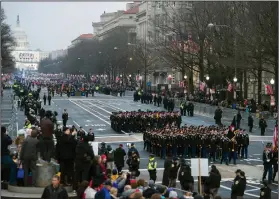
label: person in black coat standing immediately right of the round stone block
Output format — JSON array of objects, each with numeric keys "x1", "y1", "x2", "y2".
[{"x1": 56, "y1": 127, "x2": 77, "y2": 185}]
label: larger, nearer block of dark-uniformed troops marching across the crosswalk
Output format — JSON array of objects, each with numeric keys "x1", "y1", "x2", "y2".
[{"x1": 143, "y1": 125, "x2": 249, "y2": 164}]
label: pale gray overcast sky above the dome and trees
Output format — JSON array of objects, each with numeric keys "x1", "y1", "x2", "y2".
[{"x1": 1, "y1": 2, "x2": 127, "y2": 51}]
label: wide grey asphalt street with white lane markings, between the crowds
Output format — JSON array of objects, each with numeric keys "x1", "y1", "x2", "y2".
[{"x1": 13, "y1": 90, "x2": 278, "y2": 198}]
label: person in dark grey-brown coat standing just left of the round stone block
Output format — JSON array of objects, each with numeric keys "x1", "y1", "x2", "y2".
[{"x1": 20, "y1": 130, "x2": 39, "y2": 186}]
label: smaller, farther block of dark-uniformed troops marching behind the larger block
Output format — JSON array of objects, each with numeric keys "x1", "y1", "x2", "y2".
[{"x1": 110, "y1": 110, "x2": 182, "y2": 132}]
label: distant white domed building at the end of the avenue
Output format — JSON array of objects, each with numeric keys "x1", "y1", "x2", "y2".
[{"x1": 12, "y1": 15, "x2": 47, "y2": 70}]
